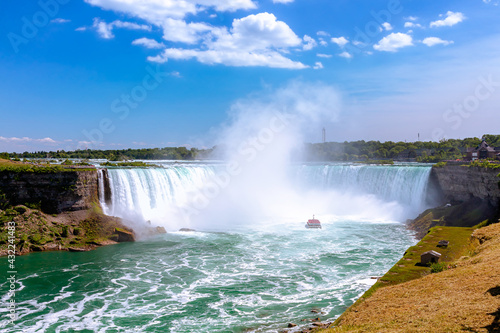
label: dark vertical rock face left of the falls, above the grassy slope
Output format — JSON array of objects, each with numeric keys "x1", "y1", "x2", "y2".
[{"x1": 0, "y1": 170, "x2": 98, "y2": 213}]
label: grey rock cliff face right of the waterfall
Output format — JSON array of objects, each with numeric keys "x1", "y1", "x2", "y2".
[{"x1": 431, "y1": 165, "x2": 500, "y2": 206}]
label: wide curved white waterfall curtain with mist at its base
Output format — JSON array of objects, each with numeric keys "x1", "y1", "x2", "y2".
[{"x1": 100, "y1": 164, "x2": 430, "y2": 230}]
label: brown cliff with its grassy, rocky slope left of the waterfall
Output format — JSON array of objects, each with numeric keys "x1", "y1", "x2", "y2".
[{"x1": 0, "y1": 165, "x2": 140, "y2": 256}]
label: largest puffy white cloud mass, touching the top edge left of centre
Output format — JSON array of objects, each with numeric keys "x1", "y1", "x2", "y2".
[{"x1": 85, "y1": 0, "x2": 304, "y2": 69}]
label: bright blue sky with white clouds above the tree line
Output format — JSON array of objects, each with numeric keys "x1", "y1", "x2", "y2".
[{"x1": 0, "y1": 0, "x2": 500, "y2": 152}]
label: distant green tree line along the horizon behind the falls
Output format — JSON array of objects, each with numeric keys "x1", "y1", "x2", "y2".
[{"x1": 0, "y1": 134, "x2": 500, "y2": 162}]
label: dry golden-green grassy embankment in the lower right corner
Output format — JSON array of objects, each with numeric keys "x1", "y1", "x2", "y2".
[{"x1": 320, "y1": 223, "x2": 500, "y2": 333}]
